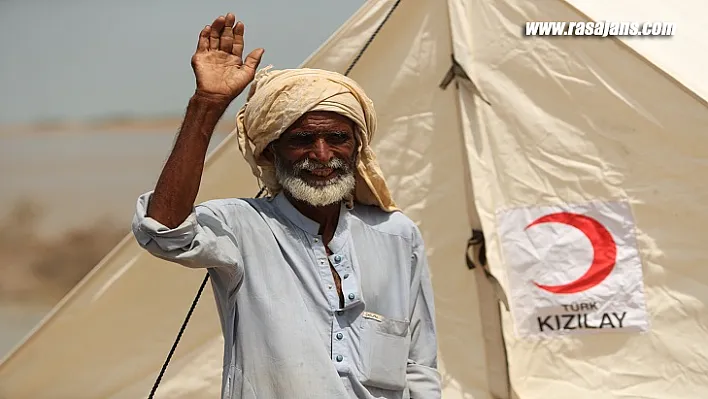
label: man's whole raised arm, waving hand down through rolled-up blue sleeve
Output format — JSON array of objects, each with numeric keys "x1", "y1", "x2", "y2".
[{"x1": 132, "y1": 14, "x2": 263, "y2": 278}]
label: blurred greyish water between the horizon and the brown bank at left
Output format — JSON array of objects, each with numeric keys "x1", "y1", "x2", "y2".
[{"x1": 0, "y1": 130, "x2": 226, "y2": 238}]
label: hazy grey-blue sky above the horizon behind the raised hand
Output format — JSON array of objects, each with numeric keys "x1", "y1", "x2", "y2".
[{"x1": 0, "y1": 0, "x2": 364, "y2": 125}]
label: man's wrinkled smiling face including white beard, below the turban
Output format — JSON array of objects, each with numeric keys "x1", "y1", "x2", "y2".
[{"x1": 272, "y1": 111, "x2": 357, "y2": 206}]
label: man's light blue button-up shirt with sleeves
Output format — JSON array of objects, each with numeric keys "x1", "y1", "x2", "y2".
[{"x1": 133, "y1": 192, "x2": 441, "y2": 399}]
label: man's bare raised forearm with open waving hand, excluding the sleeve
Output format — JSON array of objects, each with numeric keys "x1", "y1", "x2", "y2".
[{"x1": 147, "y1": 13, "x2": 263, "y2": 228}]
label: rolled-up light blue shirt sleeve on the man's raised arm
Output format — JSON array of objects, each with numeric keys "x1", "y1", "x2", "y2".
[{"x1": 132, "y1": 191, "x2": 244, "y2": 286}]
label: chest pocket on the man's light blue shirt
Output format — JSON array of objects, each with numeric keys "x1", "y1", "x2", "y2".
[{"x1": 361, "y1": 317, "x2": 411, "y2": 391}]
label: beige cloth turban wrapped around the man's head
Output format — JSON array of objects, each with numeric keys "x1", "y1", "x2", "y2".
[{"x1": 236, "y1": 68, "x2": 398, "y2": 212}]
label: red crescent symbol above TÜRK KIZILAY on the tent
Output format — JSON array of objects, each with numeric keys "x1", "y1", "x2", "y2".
[{"x1": 525, "y1": 212, "x2": 617, "y2": 294}]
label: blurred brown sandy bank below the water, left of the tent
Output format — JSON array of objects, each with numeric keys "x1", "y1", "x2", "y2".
[{"x1": 0, "y1": 202, "x2": 125, "y2": 359}]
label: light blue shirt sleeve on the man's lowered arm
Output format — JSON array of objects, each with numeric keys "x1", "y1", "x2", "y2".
[{"x1": 406, "y1": 229, "x2": 442, "y2": 399}]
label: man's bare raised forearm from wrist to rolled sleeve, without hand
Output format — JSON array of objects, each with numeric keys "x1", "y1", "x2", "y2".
[{"x1": 147, "y1": 93, "x2": 230, "y2": 228}]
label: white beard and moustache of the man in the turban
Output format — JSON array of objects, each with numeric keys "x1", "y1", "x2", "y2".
[{"x1": 275, "y1": 157, "x2": 356, "y2": 206}]
